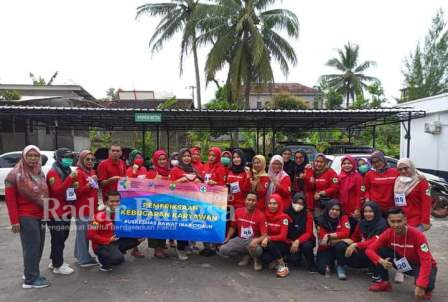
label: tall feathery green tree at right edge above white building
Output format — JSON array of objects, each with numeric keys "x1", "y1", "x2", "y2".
[{"x1": 400, "y1": 9, "x2": 448, "y2": 102}]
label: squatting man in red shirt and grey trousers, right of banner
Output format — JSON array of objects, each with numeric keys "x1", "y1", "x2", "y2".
[{"x1": 218, "y1": 192, "x2": 268, "y2": 270}]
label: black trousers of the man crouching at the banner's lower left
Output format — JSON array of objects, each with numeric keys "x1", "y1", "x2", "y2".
[{"x1": 95, "y1": 238, "x2": 140, "y2": 268}]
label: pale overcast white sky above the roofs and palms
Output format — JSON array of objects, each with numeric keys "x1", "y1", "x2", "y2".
[{"x1": 0, "y1": 0, "x2": 448, "y2": 103}]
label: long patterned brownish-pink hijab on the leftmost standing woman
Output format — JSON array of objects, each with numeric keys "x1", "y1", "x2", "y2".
[{"x1": 5, "y1": 145, "x2": 49, "y2": 207}]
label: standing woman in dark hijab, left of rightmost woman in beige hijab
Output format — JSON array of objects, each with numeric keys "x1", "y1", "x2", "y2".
[{"x1": 364, "y1": 151, "x2": 399, "y2": 215}]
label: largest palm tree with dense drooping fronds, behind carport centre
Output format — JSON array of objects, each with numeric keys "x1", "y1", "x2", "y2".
[{"x1": 198, "y1": 0, "x2": 299, "y2": 108}]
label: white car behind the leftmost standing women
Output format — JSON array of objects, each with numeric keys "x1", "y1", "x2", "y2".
[{"x1": 0, "y1": 151, "x2": 55, "y2": 196}]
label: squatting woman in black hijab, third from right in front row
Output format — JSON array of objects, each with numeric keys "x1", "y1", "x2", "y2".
[{"x1": 316, "y1": 199, "x2": 350, "y2": 280}]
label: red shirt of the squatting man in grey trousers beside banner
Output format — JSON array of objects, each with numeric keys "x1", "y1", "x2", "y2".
[{"x1": 230, "y1": 208, "x2": 268, "y2": 238}]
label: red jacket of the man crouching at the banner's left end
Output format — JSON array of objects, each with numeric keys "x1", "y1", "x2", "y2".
[{"x1": 87, "y1": 211, "x2": 115, "y2": 251}]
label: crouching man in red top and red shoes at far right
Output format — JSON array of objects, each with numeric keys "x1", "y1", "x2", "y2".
[{"x1": 366, "y1": 207, "x2": 437, "y2": 300}]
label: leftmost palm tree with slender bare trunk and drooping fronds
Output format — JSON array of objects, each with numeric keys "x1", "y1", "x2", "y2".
[{"x1": 136, "y1": 0, "x2": 207, "y2": 108}]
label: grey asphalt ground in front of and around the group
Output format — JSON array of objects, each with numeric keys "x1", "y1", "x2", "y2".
[{"x1": 0, "y1": 202, "x2": 448, "y2": 302}]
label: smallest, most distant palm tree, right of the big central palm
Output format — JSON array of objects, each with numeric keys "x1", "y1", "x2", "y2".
[{"x1": 321, "y1": 42, "x2": 378, "y2": 108}]
